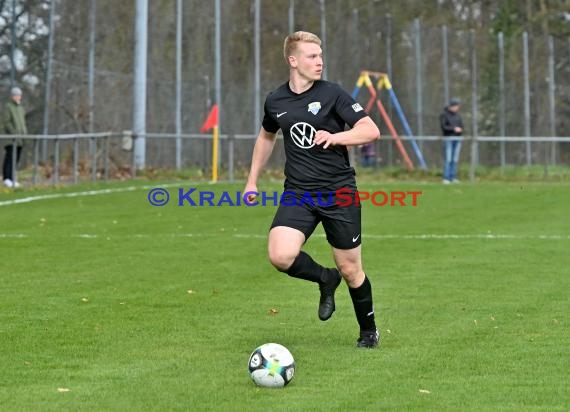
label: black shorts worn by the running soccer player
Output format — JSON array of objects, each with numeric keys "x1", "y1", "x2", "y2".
[{"x1": 271, "y1": 192, "x2": 362, "y2": 250}]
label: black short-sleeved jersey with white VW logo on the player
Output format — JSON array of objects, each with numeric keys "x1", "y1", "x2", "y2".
[{"x1": 263, "y1": 80, "x2": 367, "y2": 192}]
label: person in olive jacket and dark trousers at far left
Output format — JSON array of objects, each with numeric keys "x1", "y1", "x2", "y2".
[{"x1": 2, "y1": 87, "x2": 28, "y2": 187}]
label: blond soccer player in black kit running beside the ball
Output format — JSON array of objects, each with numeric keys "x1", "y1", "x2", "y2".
[{"x1": 244, "y1": 31, "x2": 380, "y2": 348}]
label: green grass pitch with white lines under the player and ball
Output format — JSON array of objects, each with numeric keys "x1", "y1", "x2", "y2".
[{"x1": 0, "y1": 180, "x2": 570, "y2": 411}]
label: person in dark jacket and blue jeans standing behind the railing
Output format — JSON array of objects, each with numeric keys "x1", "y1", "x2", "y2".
[{"x1": 439, "y1": 99, "x2": 463, "y2": 184}]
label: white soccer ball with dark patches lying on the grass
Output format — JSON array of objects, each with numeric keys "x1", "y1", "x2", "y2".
[{"x1": 248, "y1": 343, "x2": 295, "y2": 388}]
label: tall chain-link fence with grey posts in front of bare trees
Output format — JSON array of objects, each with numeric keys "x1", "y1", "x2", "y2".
[{"x1": 6, "y1": 0, "x2": 570, "y2": 183}]
